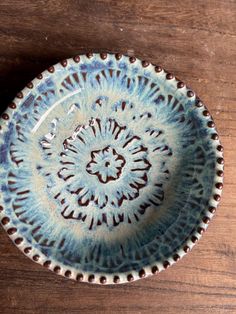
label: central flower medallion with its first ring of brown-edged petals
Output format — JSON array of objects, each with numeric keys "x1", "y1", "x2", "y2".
[{"x1": 55, "y1": 119, "x2": 151, "y2": 209}]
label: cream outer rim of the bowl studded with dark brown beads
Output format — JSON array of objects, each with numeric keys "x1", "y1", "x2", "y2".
[{"x1": 0, "y1": 52, "x2": 224, "y2": 285}]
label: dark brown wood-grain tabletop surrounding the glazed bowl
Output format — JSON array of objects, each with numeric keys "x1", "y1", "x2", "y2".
[{"x1": 0, "y1": 0, "x2": 236, "y2": 314}]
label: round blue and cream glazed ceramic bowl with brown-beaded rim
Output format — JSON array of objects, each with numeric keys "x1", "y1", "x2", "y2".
[{"x1": 0, "y1": 53, "x2": 224, "y2": 284}]
